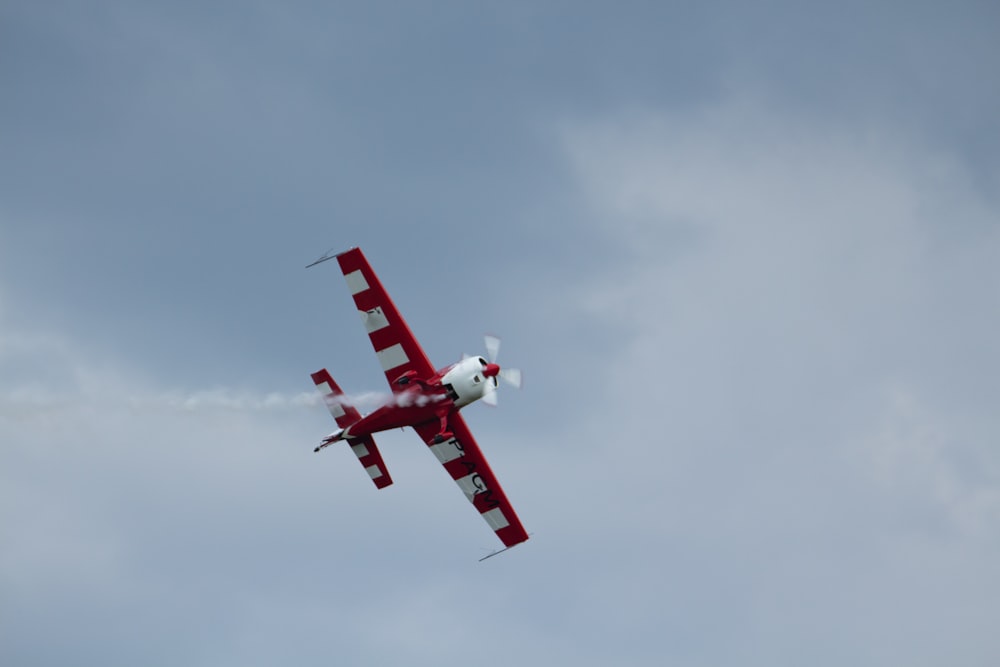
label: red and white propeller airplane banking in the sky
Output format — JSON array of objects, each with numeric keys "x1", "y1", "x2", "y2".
[{"x1": 307, "y1": 248, "x2": 528, "y2": 558}]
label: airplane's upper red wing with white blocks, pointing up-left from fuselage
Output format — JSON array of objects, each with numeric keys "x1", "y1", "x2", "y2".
[{"x1": 337, "y1": 248, "x2": 435, "y2": 392}]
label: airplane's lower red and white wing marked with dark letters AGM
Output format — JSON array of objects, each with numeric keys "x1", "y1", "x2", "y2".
[{"x1": 413, "y1": 412, "x2": 528, "y2": 547}]
